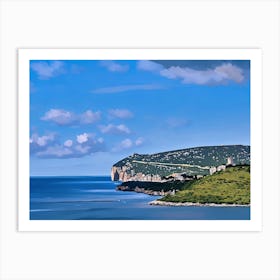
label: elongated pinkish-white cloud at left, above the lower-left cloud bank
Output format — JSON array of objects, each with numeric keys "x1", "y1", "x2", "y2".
[{"x1": 41, "y1": 109, "x2": 101, "y2": 125}]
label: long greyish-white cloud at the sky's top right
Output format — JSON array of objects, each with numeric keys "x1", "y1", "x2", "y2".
[{"x1": 160, "y1": 63, "x2": 244, "y2": 85}]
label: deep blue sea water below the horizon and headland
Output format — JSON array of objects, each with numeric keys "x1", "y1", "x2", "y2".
[{"x1": 30, "y1": 176, "x2": 250, "y2": 220}]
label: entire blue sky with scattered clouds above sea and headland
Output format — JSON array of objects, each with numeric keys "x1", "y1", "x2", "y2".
[{"x1": 30, "y1": 60, "x2": 250, "y2": 176}]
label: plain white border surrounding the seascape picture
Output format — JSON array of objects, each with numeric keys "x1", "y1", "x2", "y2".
[{"x1": 18, "y1": 49, "x2": 262, "y2": 231}]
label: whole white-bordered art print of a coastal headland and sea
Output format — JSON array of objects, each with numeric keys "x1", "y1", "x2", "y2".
[{"x1": 18, "y1": 49, "x2": 262, "y2": 231}]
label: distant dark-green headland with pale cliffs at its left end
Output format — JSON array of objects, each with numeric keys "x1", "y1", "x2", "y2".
[{"x1": 111, "y1": 145, "x2": 250, "y2": 181}]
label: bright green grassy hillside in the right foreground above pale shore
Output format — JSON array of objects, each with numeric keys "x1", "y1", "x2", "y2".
[{"x1": 159, "y1": 166, "x2": 250, "y2": 205}]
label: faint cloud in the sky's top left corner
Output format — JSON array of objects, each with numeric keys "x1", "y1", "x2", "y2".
[{"x1": 30, "y1": 61, "x2": 64, "y2": 80}]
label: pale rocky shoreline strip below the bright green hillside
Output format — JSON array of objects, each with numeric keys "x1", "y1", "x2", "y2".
[{"x1": 149, "y1": 200, "x2": 250, "y2": 207}]
